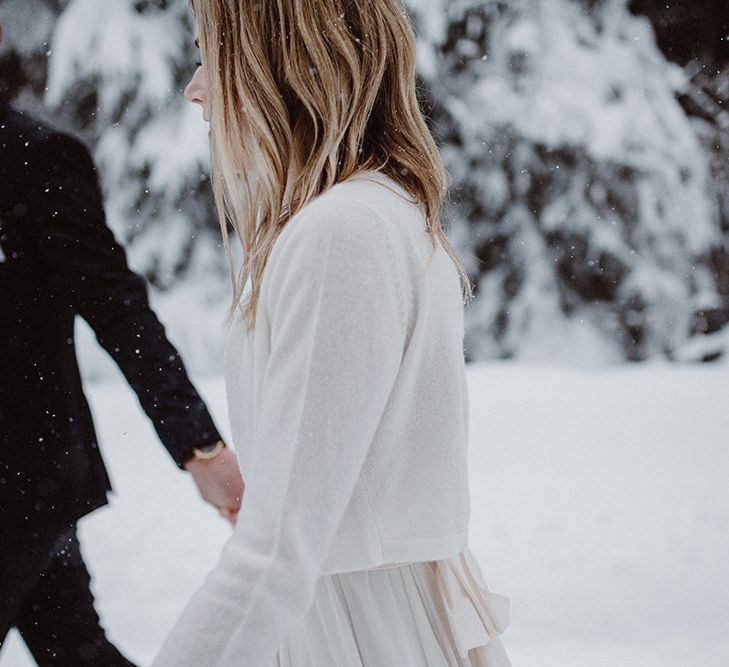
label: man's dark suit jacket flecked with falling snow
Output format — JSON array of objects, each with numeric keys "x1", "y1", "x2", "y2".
[{"x1": 0, "y1": 104, "x2": 220, "y2": 542}]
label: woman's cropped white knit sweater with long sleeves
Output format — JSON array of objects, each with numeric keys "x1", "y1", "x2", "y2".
[{"x1": 154, "y1": 173, "x2": 469, "y2": 667}]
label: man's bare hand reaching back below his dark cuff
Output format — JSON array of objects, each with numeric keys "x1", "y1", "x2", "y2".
[{"x1": 184, "y1": 447, "x2": 244, "y2": 525}]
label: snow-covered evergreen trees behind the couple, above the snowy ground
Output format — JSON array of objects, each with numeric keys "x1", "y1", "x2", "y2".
[{"x1": 0, "y1": 0, "x2": 729, "y2": 376}]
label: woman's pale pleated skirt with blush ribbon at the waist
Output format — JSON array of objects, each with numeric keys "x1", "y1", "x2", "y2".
[{"x1": 272, "y1": 550, "x2": 511, "y2": 667}]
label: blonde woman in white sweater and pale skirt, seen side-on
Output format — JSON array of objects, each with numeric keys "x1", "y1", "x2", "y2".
[{"x1": 155, "y1": 0, "x2": 509, "y2": 667}]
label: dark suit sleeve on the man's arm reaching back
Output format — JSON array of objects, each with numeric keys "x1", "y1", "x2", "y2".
[{"x1": 19, "y1": 134, "x2": 220, "y2": 465}]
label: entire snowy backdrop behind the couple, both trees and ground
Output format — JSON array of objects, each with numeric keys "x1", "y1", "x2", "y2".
[{"x1": 0, "y1": 0, "x2": 729, "y2": 667}]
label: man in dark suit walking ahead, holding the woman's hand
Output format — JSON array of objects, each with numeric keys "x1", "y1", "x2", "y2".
[{"x1": 0, "y1": 25, "x2": 243, "y2": 667}]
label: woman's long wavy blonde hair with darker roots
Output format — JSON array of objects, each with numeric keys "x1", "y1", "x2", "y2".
[{"x1": 192, "y1": 0, "x2": 472, "y2": 329}]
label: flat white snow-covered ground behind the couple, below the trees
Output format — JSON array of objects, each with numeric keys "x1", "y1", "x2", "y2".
[{"x1": 0, "y1": 363, "x2": 729, "y2": 667}]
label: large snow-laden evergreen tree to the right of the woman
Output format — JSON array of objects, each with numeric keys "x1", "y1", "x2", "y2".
[{"x1": 412, "y1": 0, "x2": 720, "y2": 360}]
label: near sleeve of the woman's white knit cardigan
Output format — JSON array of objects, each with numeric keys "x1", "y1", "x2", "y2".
[{"x1": 154, "y1": 198, "x2": 405, "y2": 667}]
